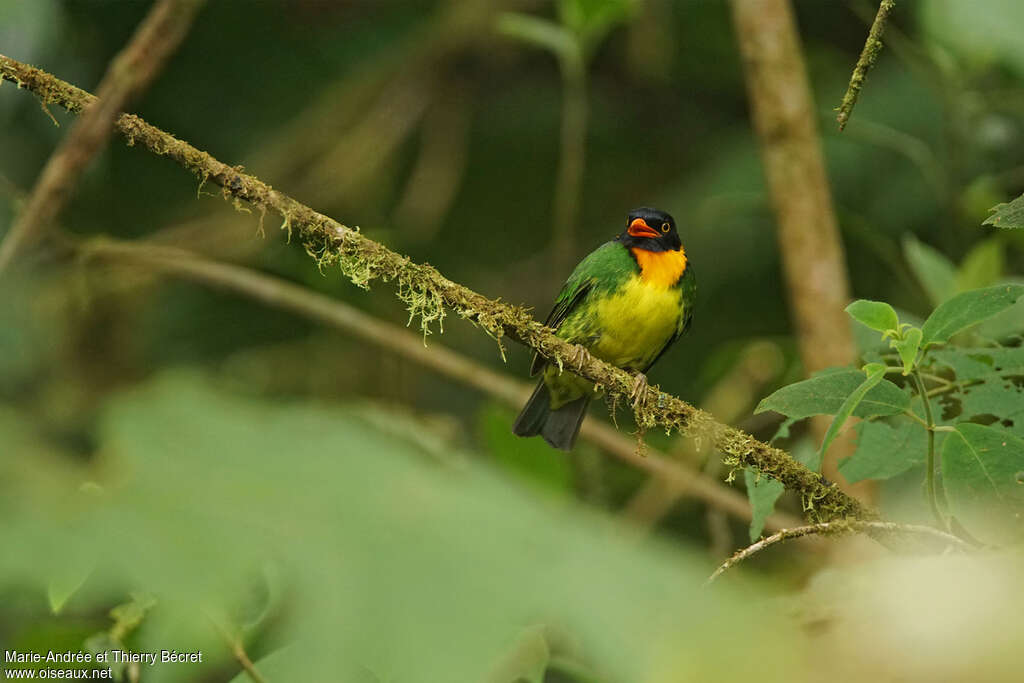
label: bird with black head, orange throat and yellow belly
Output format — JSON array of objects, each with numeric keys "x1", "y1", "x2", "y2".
[{"x1": 512, "y1": 207, "x2": 696, "y2": 451}]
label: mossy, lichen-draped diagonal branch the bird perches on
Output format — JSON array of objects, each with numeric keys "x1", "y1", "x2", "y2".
[{"x1": 0, "y1": 55, "x2": 874, "y2": 519}]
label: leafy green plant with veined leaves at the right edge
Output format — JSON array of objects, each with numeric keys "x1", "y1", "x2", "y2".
[{"x1": 749, "y1": 282, "x2": 1024, "y2": 543}]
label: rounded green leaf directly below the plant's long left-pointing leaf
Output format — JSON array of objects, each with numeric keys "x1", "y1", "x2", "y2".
[{"x1": 839, "y1": 420, "x2": 928, "y2": 483}]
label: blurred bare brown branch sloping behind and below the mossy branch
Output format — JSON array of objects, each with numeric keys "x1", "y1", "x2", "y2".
[{"x1": 77, "y1": 239, "x2": 800, "y2": 530}]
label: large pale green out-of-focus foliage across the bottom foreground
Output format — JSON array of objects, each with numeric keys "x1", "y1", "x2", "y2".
[{"x1": 0, "y1": 372, "x2": 798, "y2": 681}]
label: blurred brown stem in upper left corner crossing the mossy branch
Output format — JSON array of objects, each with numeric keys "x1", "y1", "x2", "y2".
[{"x1": 0, "y1": 0, "x2": 203, "y2": 273}]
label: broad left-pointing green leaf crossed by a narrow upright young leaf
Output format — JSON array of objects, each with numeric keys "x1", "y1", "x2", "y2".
[{"x1": 755, "y1": 368, "x2": 910, "y2": 420}]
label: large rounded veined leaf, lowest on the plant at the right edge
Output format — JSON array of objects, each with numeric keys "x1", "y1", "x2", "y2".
[{"x1": 942, "y1": 423, "x2": 1024, "y2": 543}]
